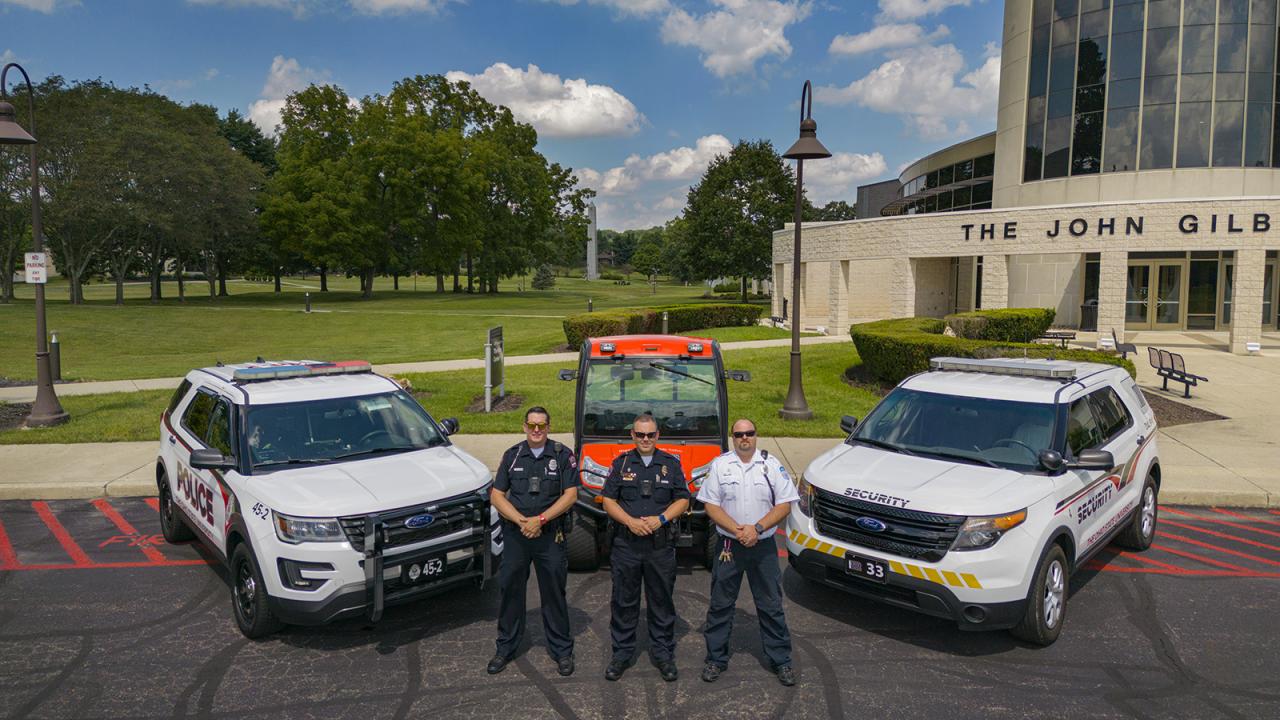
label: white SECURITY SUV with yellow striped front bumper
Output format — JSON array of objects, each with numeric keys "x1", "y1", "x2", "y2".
[{"x1": 787, "y1": 357, "x2": 1160, "y2": 644}]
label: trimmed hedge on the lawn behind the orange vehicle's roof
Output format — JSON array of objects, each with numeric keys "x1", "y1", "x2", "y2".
[{"x1": 564, "y1": 304, "x2": 764, "y2": 347}]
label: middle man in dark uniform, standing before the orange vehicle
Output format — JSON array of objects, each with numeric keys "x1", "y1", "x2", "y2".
[{"x1": 602, "y1": 415, "x2": 690, "y2": 683}]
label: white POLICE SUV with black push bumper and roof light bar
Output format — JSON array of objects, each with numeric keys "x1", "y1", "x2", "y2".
[{"x1": 156, "y1": 361, "x2": 502, "y2": 638}]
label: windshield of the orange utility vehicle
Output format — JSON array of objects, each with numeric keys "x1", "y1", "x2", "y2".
[{"x1": 582, "y1": 357, "x2": 719, "y2": 438}]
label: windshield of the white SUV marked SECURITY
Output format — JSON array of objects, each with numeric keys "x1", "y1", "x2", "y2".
[{"x1": 851, "y1": 388, "x2": 1055, "y2": 471}]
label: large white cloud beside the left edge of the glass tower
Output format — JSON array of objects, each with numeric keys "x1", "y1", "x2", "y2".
[{"x1": 814, "y1": 45, "x2": 1000, "y2": 138}]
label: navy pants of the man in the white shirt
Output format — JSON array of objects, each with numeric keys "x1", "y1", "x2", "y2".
[{"x1": 704, "y1": 530, "x2": 791, "y2": 669}]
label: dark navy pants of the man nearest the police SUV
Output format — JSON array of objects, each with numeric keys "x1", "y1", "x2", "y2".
[{"x1": 498, "y1": 520, "x2": 573, "y2": 660}]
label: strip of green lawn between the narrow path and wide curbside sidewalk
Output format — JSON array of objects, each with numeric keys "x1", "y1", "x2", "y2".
[{"x1": 0, "y1": 343, "x2": 878, "y2": 445}]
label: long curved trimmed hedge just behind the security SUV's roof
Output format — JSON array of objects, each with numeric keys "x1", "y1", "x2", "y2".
[{"x1": 849, "y1": 318, "x2": 1138, "y2": 384}]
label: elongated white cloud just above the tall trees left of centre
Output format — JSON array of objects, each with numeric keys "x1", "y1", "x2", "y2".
[{"x1": 445, "y1": 63, "x2": 644, "y2": 137}]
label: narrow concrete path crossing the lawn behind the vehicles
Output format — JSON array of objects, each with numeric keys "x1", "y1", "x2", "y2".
[{"x1": 0, "y1": 336, "x2": 851, "y2": 402}]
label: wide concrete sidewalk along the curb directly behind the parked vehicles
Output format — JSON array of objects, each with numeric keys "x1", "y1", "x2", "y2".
[{"x1": 0, "y1": 421, "x2": 1280, "y2": 507}]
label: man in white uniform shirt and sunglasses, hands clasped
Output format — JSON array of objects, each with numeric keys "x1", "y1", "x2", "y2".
[{"x1": 698, "y1": 419, "x2": 800, "y2": 687}]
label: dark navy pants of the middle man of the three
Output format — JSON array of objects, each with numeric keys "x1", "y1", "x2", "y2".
[{"x1": 609, "y1": 528, "x2": 676, "y2": 662}]
